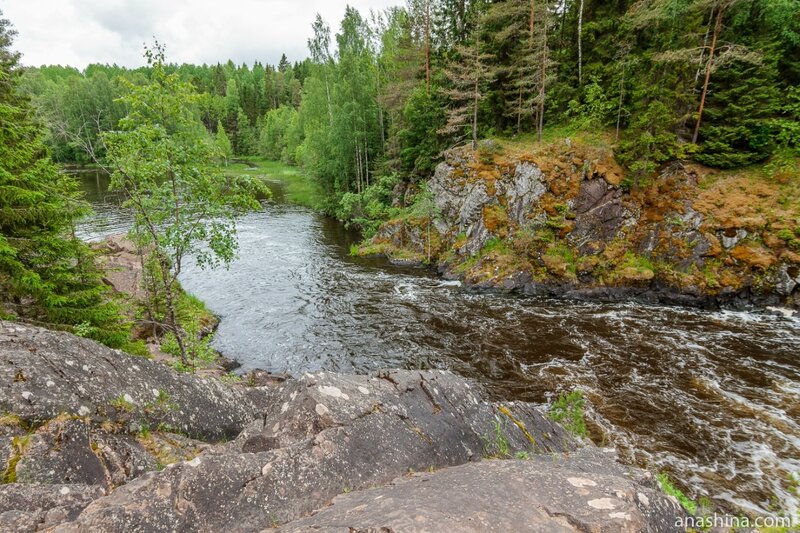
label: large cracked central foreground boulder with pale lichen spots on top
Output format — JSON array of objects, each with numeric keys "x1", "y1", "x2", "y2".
[{"x1": 57, "y1": 371, "x2": 577, "y2": 532}]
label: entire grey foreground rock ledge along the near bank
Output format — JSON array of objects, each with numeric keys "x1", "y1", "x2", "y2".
[{"x1": 0, "y1": 322, "x2": 682, "y2": 532}]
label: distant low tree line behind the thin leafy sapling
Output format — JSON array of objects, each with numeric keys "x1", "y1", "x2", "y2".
[{"x1": 22, "y1": 56, "x2": 306, "y2": 162}]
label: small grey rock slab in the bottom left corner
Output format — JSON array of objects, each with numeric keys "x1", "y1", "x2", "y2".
[{"x1": 0, "y1": 483, "x2": 104, "y2": 533}]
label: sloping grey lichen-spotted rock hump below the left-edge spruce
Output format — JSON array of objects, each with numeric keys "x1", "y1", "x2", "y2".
[{"x1": 0, "y1": 321, "x2": 267, "y2": 440}]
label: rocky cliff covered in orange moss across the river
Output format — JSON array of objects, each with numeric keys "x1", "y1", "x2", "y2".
[{"x1": 361, "y1": 139, "x2": 800, "y2": 307}]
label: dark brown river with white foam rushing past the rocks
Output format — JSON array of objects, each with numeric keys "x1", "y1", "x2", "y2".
[{"x1": 76, "y1": 168, "x2": 800, "y2": 513}]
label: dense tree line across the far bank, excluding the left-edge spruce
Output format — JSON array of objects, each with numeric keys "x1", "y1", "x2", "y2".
[{"x1": 18, "y1": 0, "x2": 800, "y2": 218}]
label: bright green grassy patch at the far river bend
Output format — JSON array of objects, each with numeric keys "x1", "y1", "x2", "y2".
[{"x1": 223, "y1": 157, "x2": 319, "y2": 207}]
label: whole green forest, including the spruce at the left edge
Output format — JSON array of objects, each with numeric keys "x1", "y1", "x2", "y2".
[{"x1": 0, "y1": 0, "x2": 800, "y2": 345}]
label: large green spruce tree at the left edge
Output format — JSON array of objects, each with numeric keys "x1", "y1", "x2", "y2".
[{"x1": 0, "y1": 14, "x2": 127, "y2": 346}]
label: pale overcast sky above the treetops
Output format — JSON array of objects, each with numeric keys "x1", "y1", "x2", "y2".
[{"x1": 0, "y1": 0, "x2": 404, "y2": 69}]
